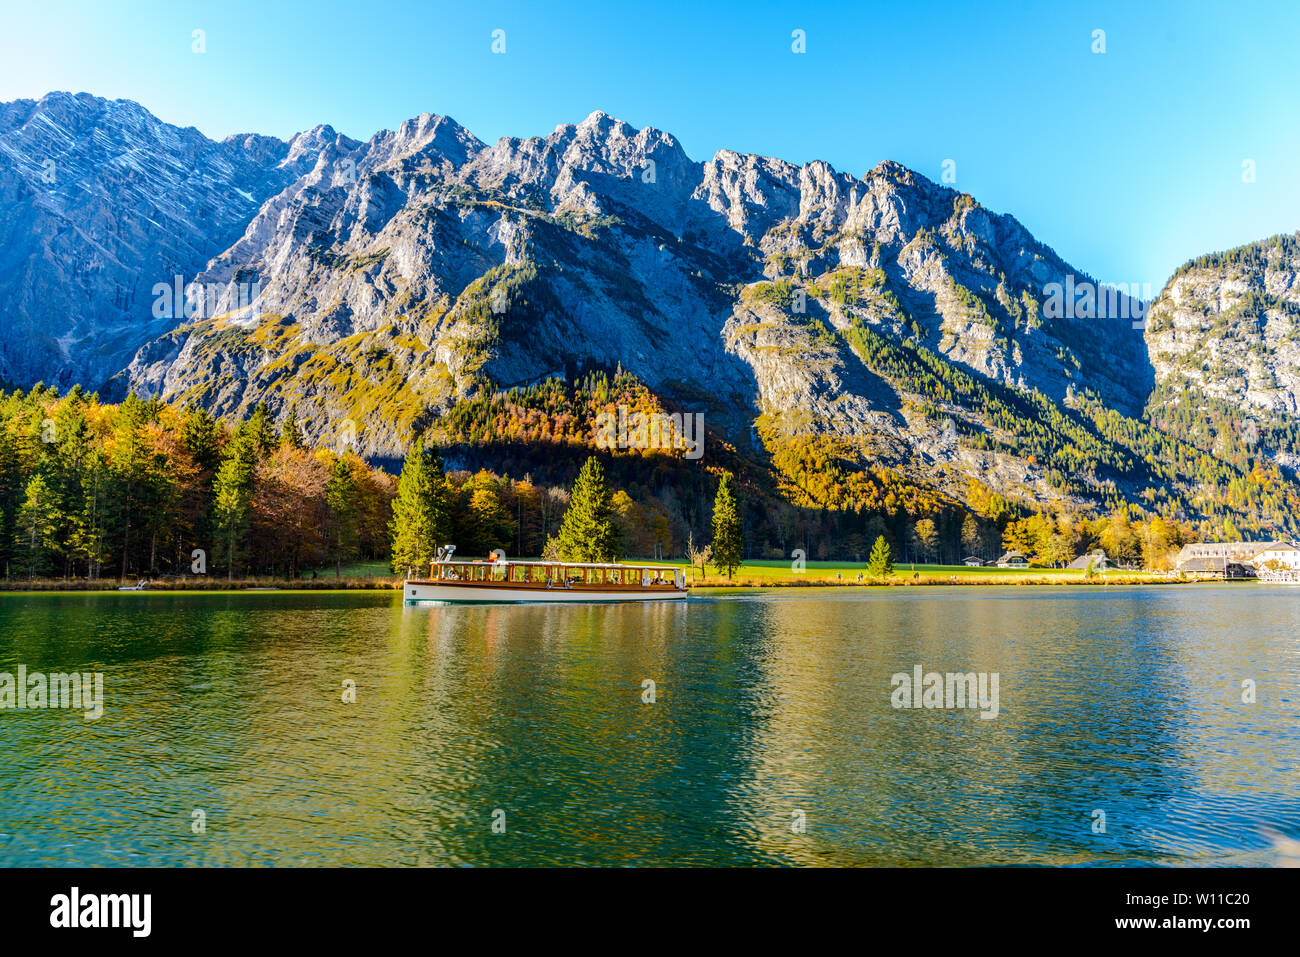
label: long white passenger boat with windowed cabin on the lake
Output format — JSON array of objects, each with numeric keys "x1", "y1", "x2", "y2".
[{"x1": 402, "y1": 549, "x2": 686, "y2": 603}]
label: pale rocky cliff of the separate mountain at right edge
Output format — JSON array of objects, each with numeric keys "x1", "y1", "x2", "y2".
[{"x1": 1147, "y1": 235, "x2": 1300, "y2": 468}]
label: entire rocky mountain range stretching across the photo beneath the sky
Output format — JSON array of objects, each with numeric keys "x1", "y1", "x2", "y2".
[{"x1": 0, "y1": 92, "x2": 1300, "y2": 529}]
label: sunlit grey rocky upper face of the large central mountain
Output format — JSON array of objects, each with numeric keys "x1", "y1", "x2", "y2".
[{"x1": 106, "y1": 104, "x2": 1145, "y2": 468}]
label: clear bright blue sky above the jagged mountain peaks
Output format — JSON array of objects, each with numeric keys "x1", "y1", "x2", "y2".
[{"x1": 0, "y1": 0, "x2": 1300, "y2": 290}]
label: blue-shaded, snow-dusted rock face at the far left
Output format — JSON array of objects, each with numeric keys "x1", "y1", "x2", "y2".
[{"x1": 0, "y1": 94, "x2": 332, "y2": 386}]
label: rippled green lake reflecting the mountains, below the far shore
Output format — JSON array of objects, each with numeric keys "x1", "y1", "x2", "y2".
[{"x1": 0, "y1": 585, "x2": 1300, "y2": 866}]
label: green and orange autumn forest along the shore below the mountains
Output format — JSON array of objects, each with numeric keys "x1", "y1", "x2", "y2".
[{"x1": 0, "y1": 374, "x2": 1239, "y2": 581}]
